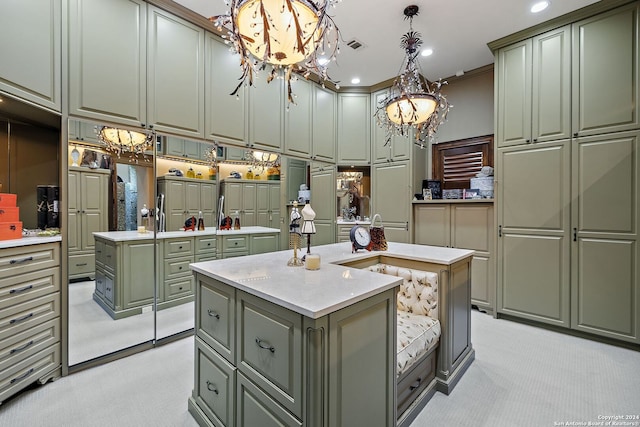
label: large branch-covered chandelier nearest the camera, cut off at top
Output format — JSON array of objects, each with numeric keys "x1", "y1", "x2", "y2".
[{"x1": 209, "y1": 0, "x2": 341, "y2": 104}]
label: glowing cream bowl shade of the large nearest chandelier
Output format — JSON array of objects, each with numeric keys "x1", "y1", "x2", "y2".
[{"x1": 236, "y1": 0, "x2": 321, "y2": 66}]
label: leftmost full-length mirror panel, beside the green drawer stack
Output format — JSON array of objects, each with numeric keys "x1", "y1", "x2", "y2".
[{"x1": 67, "y1": 120, "x2": 156, "y2": 366}]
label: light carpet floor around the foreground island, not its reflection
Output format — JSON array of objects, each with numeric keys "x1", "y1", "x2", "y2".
[{"x1": 0, "y1": 311, "x2": 640, "y2": 427}]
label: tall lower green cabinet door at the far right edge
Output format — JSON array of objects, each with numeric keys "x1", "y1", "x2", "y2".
[{"x1": 571, "y1": 131, "x2": 640, "y2": 343}]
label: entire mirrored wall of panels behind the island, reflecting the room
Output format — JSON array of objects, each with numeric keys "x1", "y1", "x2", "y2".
[{"x1": 67, "y1": 120, "x2": 309, "y2": 366}]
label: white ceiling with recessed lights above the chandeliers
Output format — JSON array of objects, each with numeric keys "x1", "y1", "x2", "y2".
[{"x1": 175, "y1": 0, "x2": 597, "y2": 87}]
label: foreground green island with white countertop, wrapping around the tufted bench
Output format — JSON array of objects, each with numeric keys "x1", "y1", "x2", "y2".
[{"x1": 189, "y1": 242, "x2": 473, "y2": 426}]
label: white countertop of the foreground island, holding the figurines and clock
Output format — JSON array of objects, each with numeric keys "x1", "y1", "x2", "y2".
[{"x1": 190, "y1": 242, "x2": 474, "y2": 319}]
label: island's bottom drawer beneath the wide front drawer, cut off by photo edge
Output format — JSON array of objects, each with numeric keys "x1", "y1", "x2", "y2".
[{"x1": 236, "y1": 373, "x2": 302, "y2": 427}]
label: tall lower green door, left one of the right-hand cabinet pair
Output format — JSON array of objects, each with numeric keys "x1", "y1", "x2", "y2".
[{"x1": 496, "y1": 140, "x2": 571, "y2": 327}]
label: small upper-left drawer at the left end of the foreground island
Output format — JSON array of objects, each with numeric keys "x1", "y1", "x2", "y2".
[{"x1": 196, "y1": 275, "x2": 236, "y2": 363}]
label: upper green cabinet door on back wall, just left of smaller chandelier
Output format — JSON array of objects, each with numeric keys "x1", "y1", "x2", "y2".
[{"x1": 337, "y1": 93, "x2": 371, "y2": 165}]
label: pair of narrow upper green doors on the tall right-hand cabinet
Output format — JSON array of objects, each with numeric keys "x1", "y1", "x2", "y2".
[{"x1": 496, "y1": 26, "x2": 571, "y2": 147}]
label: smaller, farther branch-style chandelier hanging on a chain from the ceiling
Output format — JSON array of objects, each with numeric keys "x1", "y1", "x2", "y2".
[{"x1": 375, "y1": 5, "x2": 452, "y2": 148}]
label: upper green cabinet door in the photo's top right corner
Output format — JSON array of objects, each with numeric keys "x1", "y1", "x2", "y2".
[{"x1": 572, "y1": 3, "x2": 640, "y2": 136}]
